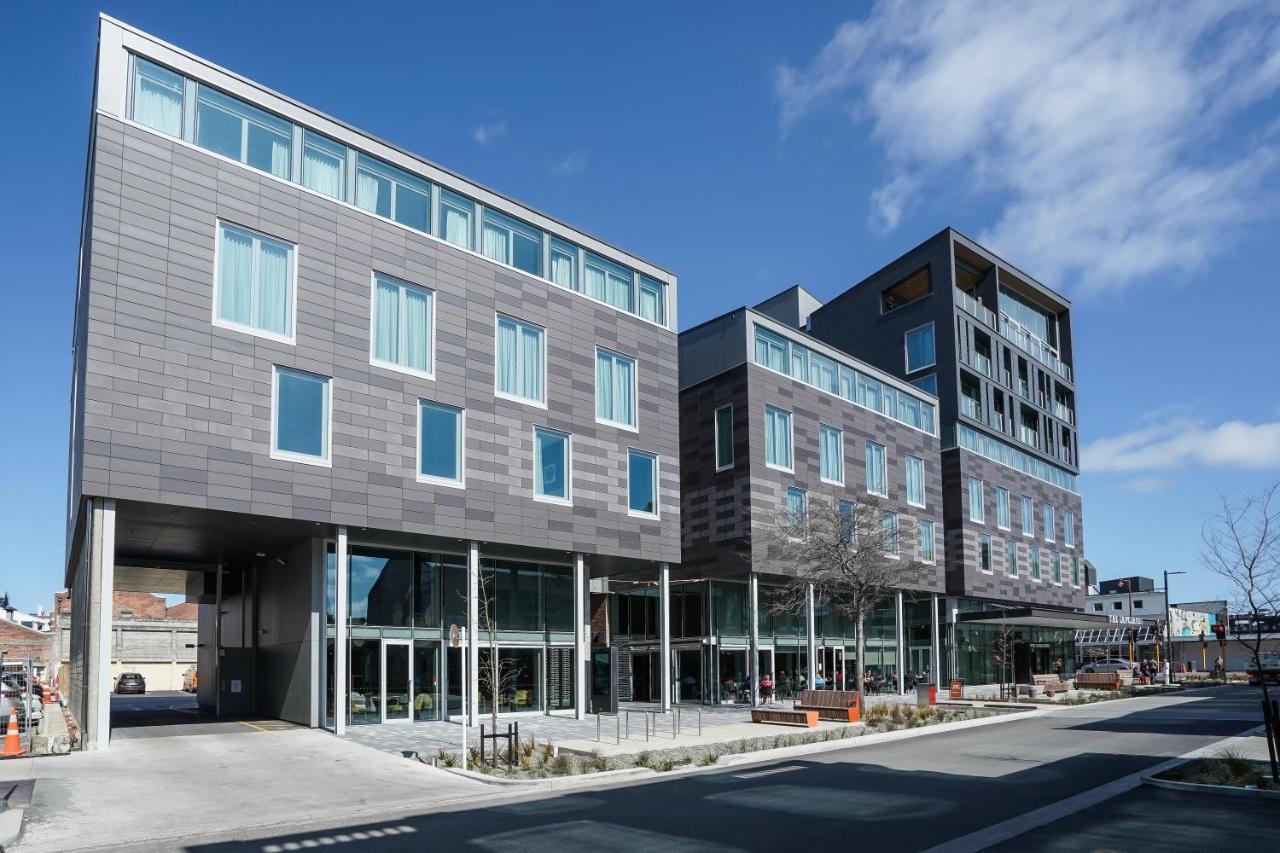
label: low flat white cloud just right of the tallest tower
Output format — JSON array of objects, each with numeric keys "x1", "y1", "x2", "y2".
[{"x1": 1080, "y1": 418, "x2": 1280, "y2": 471}]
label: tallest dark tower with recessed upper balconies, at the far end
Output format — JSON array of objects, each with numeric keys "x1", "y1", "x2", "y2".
[{"x1": 808, "y1": 228, "x2": 1088, "y2": 681}]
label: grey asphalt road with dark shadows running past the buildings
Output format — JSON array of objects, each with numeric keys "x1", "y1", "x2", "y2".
[{"x1": 170, "y1": 688, "x2": 1268, "y2": 853}]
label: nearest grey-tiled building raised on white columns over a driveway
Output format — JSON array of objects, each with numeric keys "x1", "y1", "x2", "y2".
[{"x1": 67, "y1": 17, "x2": 680, "y2": 747}]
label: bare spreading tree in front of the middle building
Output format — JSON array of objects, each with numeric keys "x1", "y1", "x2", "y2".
[{"x1": 764, "y1": 497, "x2": 937, "y2": 690}]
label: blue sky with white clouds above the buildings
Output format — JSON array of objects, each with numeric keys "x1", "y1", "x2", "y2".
[{"x1": 0, "y1": 0, "x2": 1280, "y2": 608}]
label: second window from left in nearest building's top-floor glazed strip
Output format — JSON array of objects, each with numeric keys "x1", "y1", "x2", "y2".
[{"x1": 196, "y1": 85, "x2": 293, "y2": 178}]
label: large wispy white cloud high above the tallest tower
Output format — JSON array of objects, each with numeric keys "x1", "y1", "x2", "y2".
[{"x1": 774, "y1": 0, "x2": 1280, "y2": 288}]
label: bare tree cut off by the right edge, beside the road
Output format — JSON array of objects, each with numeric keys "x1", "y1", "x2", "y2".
[{"x1": 1201, "y1": 483, "x2": 1280, "y2": 783}]
